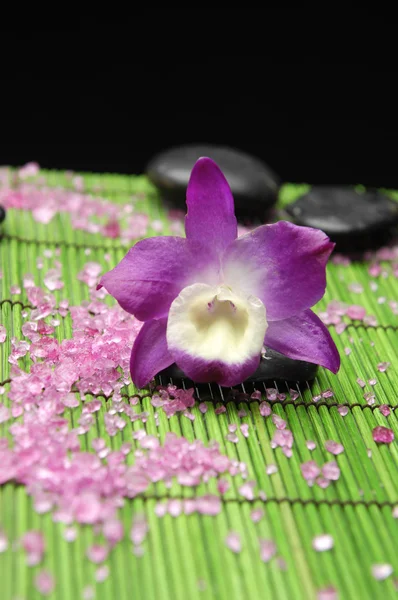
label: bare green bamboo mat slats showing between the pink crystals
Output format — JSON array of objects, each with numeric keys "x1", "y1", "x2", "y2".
[{"x1": 0, "y1": 172, "x2": 398, "y2": 600}]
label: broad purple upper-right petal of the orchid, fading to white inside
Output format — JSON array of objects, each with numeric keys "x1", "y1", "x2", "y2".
[{"x1": 223, "y1": 221, "x2": 334, "y2": 321}]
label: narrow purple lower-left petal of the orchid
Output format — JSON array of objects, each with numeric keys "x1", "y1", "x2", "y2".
[{"x1": 130, "y1": 319, "x2": 174, "y2": 388}]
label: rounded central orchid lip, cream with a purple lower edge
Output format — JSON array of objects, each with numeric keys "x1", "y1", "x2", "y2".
[{"x1": 167, "y1": 284, "x2": 267, "y2": 386}]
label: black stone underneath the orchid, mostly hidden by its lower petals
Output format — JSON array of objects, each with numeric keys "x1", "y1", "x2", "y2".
[{"x1": 158, "y1": 348, "x2": 318, "y2": 385}]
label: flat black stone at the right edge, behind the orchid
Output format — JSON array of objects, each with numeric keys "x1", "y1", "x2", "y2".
[{"x1": 286, "y1": 186, "x2": 398, "y2": 251}]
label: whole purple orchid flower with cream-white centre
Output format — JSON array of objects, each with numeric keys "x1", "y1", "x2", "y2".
[{"x1": 99, "y1": 158, "x2": 340, "y2": 388}]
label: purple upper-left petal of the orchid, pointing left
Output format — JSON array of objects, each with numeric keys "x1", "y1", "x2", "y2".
[{"x1": 100, "y1": 236, "x2": 219, "y2": 321}]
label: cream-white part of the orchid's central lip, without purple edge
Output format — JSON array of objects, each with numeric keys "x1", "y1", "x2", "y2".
[{"x1": 167, "y1": 283, "x2": 268, "y2": 365}]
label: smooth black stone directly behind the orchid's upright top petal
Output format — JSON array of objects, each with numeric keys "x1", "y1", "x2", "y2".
[{"x1": 146, "y1": 144, "x2": 280, "y2": 220}]
